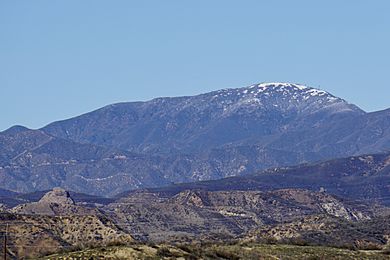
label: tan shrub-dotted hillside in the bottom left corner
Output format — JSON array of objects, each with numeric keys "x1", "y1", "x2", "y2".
[{"x1": 0, "y1": 213, "x2": 134, "y2": 259}]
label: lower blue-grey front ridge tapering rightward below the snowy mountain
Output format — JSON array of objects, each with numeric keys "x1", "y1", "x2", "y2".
[{"x1": 0, "y1": 128, "x2": 304, "y2": 195}]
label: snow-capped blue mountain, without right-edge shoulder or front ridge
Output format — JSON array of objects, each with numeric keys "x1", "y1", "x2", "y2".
[{"x1": 42, "y1": 83, "x2": 365, "y2": 153}]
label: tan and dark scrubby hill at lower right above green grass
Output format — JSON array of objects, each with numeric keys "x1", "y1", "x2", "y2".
[{"x1": 244, "y1": 215, "x2": 390, "y2": 249}]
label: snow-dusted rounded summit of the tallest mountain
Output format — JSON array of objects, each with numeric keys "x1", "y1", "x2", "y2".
[{"x1": 207, "y1": 82, "x2": 364, "y2": 114}]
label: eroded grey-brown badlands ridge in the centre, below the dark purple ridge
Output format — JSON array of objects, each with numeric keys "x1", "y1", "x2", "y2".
[{"x1": 106, "y1": 189, "x2": 376, "y2": 241}]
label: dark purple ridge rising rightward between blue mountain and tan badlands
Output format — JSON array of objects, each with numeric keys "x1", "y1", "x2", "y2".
[{"x1": 129, "y1": 152, "x2": 390, "y2": 206}]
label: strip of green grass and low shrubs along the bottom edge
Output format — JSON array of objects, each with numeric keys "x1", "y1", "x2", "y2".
[{"x1": 42, "y1": 244, "x2": 389, "y2": 260}]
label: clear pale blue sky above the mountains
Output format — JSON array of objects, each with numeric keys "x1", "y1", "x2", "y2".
[{"x1": 0, "y1": 0, "x2": 390, "y2": 130}]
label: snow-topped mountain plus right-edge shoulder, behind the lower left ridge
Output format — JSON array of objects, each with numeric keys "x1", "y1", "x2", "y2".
[{"x1": 42, "y1": 83, "x2": 390, "y2": 162}]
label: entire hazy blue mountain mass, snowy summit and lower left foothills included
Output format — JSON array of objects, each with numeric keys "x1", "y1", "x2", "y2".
[{"x1": 0, "y1": 83, "x2": 390, "y2": 196}]
